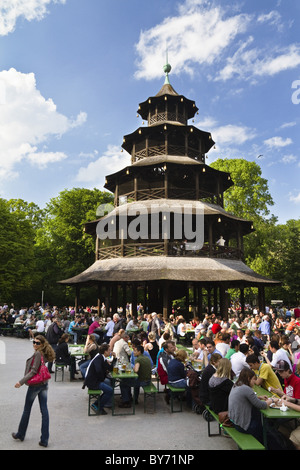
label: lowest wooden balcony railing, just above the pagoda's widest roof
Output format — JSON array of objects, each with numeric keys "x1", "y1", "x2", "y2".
[{"x1": 97, "y1": 242, "x2": 243, "y2": 260}]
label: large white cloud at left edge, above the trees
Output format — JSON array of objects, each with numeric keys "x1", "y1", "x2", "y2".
[{"x1": 0, "y1": 68, "x2": 86, "y2": 177}]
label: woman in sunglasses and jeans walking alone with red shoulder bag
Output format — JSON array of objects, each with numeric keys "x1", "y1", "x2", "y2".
[{"x1": 12, "y1": 335, "x2": 55, "y2": 447}]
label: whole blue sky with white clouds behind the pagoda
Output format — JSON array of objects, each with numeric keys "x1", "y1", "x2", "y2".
[{"x1": 0, "y1": 0, "x2": 300, "y2": 224}]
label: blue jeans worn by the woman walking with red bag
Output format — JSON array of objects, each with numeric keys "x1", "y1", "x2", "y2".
[{"x1": 17, "y1": 383, "x2": 49, "y2": 444}]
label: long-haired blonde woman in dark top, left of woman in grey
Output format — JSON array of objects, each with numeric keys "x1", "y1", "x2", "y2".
[{"x1": 208, "y1": 358, "x2": 233, "y2": 413}]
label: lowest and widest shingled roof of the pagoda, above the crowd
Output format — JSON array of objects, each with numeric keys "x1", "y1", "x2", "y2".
[{"x1": 59, "y1": 256, "x2": 280, "y2": 287}]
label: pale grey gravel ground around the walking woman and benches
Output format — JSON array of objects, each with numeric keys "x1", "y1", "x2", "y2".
[{"x1": 0, "y1": 336, "x2": 236, "y2": 458}]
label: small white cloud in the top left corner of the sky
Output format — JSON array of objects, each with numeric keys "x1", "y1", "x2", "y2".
[{"x1": 0, "y1": 0, "x2": 66, "y2": 36}]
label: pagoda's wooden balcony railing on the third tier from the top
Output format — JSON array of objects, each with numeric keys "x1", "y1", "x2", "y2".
[{"x1": 116, "y1": 187, "x2": 217, "y2": 204}]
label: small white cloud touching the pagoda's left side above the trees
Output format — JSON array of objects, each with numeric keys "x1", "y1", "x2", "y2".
[{"x1": 76, "y1": 145, "x2": 130, "y2": 188}]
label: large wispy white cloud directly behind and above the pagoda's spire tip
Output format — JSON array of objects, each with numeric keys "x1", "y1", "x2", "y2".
[{"x1": 135, "y1": 0, "x2": 251, "y2": 80}]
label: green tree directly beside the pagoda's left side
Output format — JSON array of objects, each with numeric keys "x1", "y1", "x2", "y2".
[{"x1": 36, "y1": 188, "x2": 113, "y2": 303}]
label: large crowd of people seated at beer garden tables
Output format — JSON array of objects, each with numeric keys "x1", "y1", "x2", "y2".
[{"x1": 4, "y1": 300, "x2": 300, "y2": 449}]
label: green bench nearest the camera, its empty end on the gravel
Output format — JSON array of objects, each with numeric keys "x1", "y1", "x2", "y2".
[{"x1": 205, "y1": 405, "x2": 265, "y2": 450}]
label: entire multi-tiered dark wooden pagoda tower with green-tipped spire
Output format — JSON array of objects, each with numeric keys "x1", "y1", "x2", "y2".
[{"x1": 59, "y1": 64, "x2": 279, "y2": 317}]
